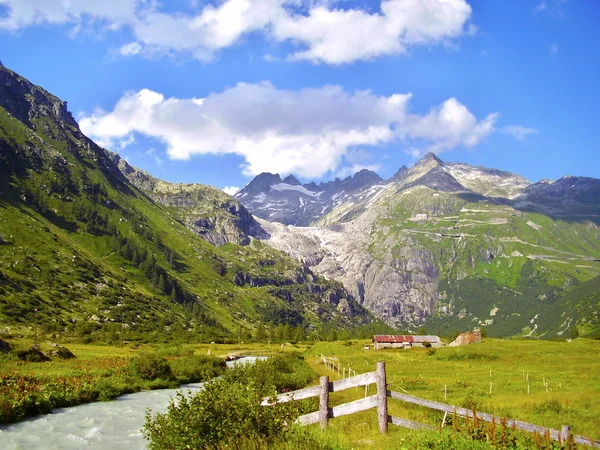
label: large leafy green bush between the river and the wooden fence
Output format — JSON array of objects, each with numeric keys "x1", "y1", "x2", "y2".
[{"x1": 143, "y1": 354, "x2": 316, "y2": 449}]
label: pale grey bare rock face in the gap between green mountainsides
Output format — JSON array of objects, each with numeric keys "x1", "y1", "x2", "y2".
[{"x1": 254, "y1": 178, "x2": 438, "y2": 327}]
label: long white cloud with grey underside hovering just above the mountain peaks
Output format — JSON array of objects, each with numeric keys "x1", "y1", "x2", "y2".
[{"x1": 80, "y1": 82, "x2": 498, "y2": 178}]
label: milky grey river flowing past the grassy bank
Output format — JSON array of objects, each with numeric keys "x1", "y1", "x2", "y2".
[{"x1": 0, "y1": 357, "x2": 256, "y2": 450}]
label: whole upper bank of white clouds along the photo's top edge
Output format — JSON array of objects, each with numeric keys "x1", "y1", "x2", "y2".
[{"x1": 0, "y1": 0, "x2": 476, "y2": 64}]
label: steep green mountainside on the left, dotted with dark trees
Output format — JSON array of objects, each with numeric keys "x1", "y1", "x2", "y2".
[{"x1": 0, "y1": 67, "x2": 368, "y2": 339}]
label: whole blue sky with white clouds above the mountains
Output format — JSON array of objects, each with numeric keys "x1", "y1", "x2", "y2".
[{"x1": 0, "y1": 0, "x2": 600, "y2": 193}]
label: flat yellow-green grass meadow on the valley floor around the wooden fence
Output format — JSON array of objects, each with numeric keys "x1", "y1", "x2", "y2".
[{"x1": 0, "y1": 339, "x2": 600, "y2": 449}]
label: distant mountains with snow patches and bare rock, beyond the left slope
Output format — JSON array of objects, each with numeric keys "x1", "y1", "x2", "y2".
[{"x1": 235, "y1": 154, "x2": 600, "y2": 337}]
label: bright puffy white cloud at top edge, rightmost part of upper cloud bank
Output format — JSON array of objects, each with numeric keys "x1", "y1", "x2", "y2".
[{"x1": 273, "y1": 0, "x2": 471, "y2": 64}]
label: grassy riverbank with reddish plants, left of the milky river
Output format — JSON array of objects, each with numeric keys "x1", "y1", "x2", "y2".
[{"x1": 0, "y1": 346, "x2": 226, "y2": 424}]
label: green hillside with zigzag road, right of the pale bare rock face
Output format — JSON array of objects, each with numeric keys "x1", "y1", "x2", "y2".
[{"x1": 370, "y1": 186, "x2": 600, "y2": 338}]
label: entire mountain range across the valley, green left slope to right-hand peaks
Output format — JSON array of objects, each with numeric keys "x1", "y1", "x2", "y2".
[{"x1": 0, "y1": 62, "x2": 600, "y2": 339}]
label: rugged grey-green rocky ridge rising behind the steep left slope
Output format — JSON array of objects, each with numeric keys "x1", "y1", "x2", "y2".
[{"x1": 110, "y1": 153, "x2": 268, "y2": 246}]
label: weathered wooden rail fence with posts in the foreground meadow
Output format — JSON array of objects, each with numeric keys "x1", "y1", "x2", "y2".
[{"x1": 262, "y1": 362, "x2": 600, "y2": 448}]
